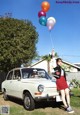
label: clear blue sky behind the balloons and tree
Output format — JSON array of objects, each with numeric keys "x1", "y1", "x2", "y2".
[{"x1": 0, "y1": 0, "x2": 80, "y2": 63}]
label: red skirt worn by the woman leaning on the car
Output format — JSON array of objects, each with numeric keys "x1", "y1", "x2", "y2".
[{"x1": 56, "y1": 76, "x2": 69, "y2": 90}]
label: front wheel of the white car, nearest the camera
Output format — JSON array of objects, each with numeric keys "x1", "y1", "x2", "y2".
[{"x1": 23, "y1": 92, "x2": 35, "y2": 110}]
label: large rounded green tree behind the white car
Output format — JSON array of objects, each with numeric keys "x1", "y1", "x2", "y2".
[{"x1": 0, "y1": 17, "x2": 38, "y2": 72}]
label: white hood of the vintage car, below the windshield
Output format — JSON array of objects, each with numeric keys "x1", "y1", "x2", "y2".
[{"x1": 22, "y1": 78, "x2": 56, "y2": 87}]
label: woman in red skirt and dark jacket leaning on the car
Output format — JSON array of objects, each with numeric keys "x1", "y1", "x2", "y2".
[{"x1": 54, "y1": 58, "x2": 74, "y2": 113}]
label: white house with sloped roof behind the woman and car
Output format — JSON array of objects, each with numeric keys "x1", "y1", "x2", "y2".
[{"x1": 29, "y1": 57, "x2": 80, "y2": 73}]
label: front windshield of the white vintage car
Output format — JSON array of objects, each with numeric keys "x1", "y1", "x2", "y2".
[{"x1": 22, "y1": 68, "x2": 51, "y2": 79}]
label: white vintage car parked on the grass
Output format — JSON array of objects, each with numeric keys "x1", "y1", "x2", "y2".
[{"x1": 2, "y1": 67, "x2": 62, "y2": 110}]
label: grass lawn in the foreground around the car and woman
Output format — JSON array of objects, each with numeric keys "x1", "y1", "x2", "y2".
[{"x1": 0, "y1": 88, "x2": 80, "y2": 115}]
